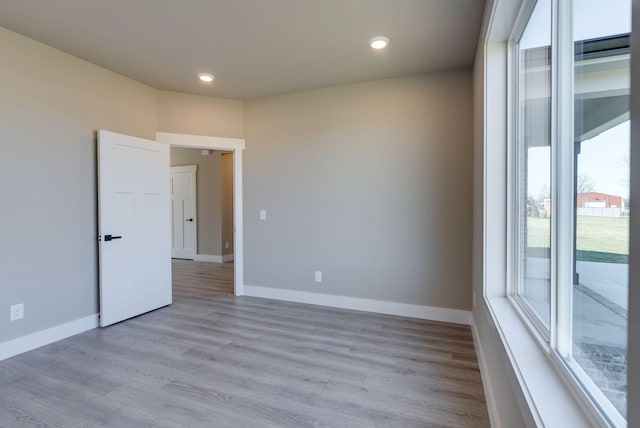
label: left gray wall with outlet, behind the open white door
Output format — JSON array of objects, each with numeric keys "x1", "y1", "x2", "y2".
[{"x1": 0, "y1": 28, "x2": 157, "y2": 343}]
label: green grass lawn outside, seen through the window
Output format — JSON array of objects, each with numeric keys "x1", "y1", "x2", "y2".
[{"x1": 527, "y1": 216, "x2": 629, "y2": 263}]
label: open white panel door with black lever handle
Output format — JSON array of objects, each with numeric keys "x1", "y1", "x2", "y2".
[{"x1": 98, "y1": 130, "x2": 171, "y2": 327}]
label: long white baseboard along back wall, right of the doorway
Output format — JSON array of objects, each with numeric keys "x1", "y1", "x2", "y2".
[{"x1": 244, "y1": 284, "x2": 471, "y2": 325}]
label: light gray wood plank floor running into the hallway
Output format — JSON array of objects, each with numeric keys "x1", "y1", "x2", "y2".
[{"x1": 0, "y1": 260, "x2": 489, "y2": 428}]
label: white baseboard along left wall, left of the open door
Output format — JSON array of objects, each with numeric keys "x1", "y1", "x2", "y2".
[{"x1": 0, "y1": 314, "x2": 98, "y2": 361}]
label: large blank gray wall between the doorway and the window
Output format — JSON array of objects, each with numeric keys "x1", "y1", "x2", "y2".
[{"x1": 243, "y1": 69, "x2": 472, "y2": 309}]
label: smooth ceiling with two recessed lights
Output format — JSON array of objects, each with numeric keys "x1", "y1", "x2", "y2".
[{"x1": 0, "y1": 0, "x2": 484, "y2": 99}]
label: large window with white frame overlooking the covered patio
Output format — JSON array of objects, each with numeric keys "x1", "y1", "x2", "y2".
[{"x1": 510, "y1": 0, "x2": 631, "y2": 426}]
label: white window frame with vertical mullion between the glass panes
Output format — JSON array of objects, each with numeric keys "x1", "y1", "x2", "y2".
[{"x1": 505, "y1": 0, "x2": 629, "y2": 427}]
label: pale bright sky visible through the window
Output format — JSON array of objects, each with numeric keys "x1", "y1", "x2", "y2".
[{"x1": 520, "y1": 0, "x2": 631, "y2": 198}]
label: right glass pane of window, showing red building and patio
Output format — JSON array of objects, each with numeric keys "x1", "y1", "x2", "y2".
[{"x1": 561, "y1": 0, "x2": 631, "y2": 417}]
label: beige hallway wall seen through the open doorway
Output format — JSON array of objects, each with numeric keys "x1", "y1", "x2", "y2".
[{"x1": 171, "y1": 147, "x2": 228, "y2": 256}]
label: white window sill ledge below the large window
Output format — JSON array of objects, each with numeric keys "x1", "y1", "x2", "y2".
[{"x1": 486, "y1": 296, "x2": 601, "y2": 427}]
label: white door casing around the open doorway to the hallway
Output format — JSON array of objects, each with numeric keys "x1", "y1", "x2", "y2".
[{"x1": 156, "y1": 132, "x2": 245, "y2": 296}]
